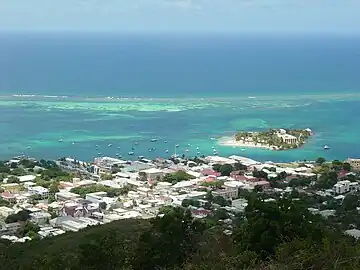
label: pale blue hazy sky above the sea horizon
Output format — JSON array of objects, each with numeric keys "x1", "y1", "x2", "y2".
[{"x1": 0, "y1": 0, "x2": 360, "y2": 34}]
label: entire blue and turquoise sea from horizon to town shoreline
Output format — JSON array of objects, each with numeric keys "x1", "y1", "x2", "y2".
[{"x1": 0, "y1": 33, "x2": 360, "y2": 161}]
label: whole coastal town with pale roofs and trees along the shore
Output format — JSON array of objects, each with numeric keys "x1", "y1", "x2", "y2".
[{"x1": 0, "y1": 156, "x2": 360, "y2": 242}]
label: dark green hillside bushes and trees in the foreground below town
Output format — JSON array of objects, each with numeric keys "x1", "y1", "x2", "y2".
[{"x1": 0, "y1": 193, "x2": 360, "y2": 270}]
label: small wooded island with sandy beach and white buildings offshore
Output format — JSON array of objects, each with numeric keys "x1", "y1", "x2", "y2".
[{"x1": 219, "y1": 128, "x2": 313, "y2": 150}]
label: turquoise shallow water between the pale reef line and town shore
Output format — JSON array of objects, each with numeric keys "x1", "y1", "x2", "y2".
[{"x1": 0, "y1": 94, "x2": 360, "y2": 161}]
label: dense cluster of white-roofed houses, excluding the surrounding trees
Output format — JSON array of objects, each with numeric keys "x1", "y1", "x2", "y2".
[{"x1": 0, "y1": 156, "x2": 359, "y2": 242}]
